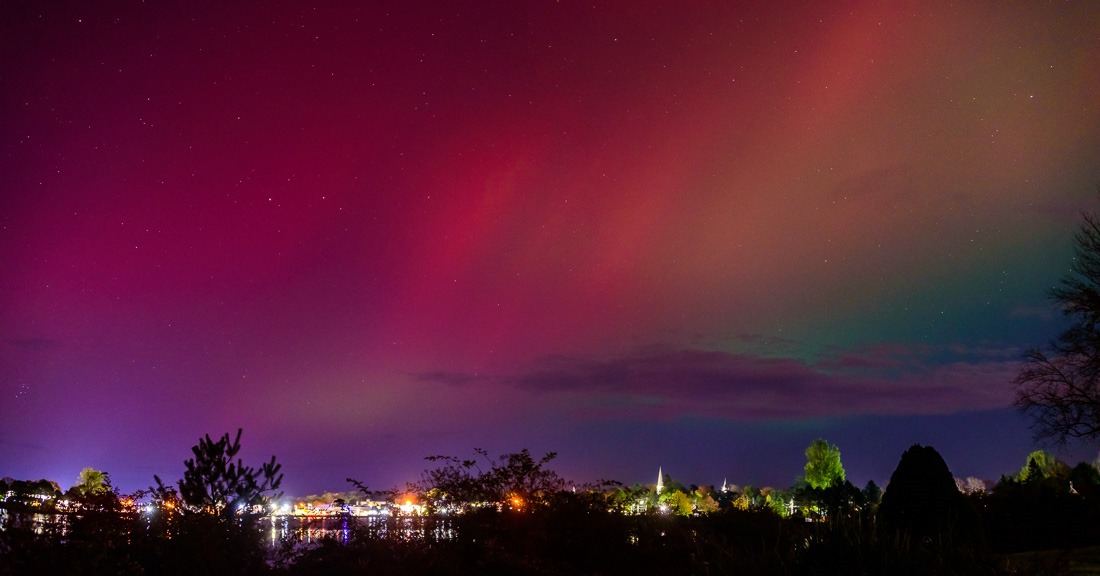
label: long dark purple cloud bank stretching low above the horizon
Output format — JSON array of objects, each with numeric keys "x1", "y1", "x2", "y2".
[{"x1": 422, "y1": 345, "x2": 1018, "y2": 420}]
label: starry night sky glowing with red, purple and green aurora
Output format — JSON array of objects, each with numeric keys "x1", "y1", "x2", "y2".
[{"x1": 0, "y1": 0, "x2": 1100, "y2": 495}]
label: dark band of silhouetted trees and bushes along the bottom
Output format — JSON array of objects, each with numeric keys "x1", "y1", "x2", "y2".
[{"x1": 0, "y1": 432, "x2": 1100, "y2": 576}]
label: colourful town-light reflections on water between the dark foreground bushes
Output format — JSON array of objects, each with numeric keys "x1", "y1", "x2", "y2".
[{"x1": 265, "y1": 516, "x2": 457, "y2": 546}]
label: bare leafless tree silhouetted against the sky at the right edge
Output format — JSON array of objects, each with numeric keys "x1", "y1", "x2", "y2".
[{"x1": 1015, "y1": 214, "x2": 1100, "y2": 444}]
